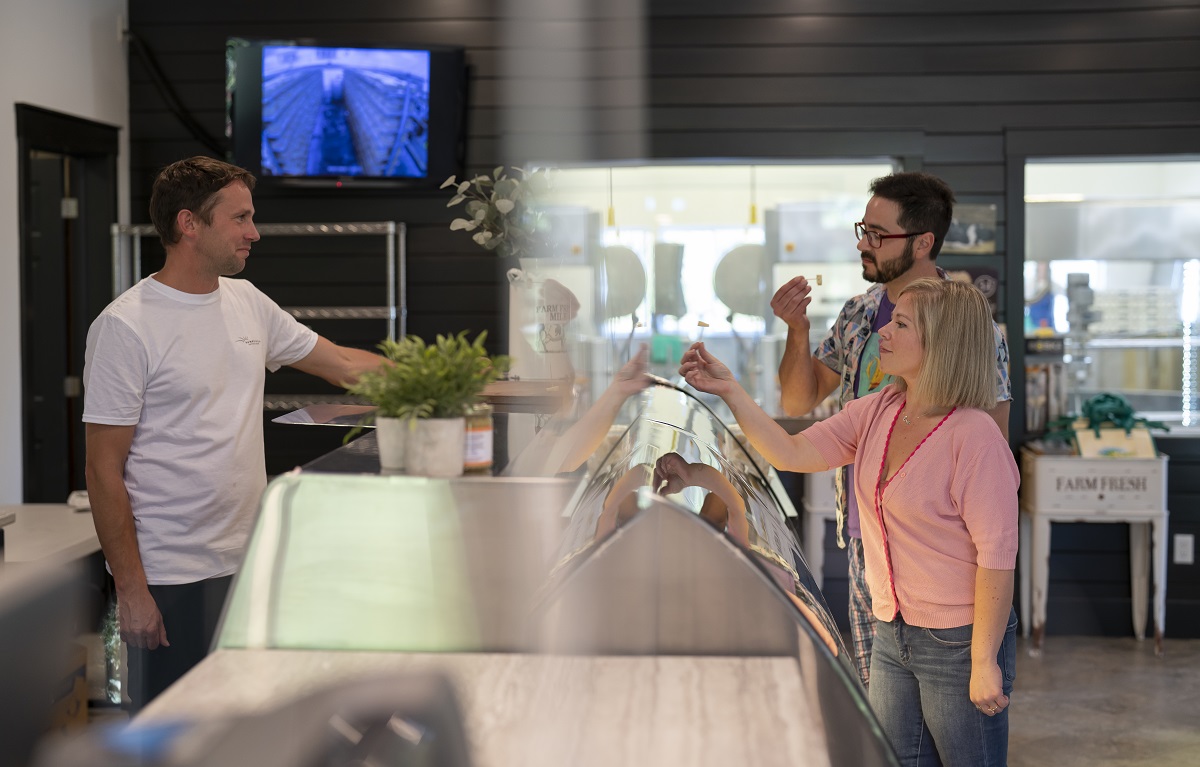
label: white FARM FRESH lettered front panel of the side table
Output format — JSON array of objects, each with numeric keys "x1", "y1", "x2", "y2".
[{"x1": 1021, "y1": 449, "x2": 1166, "y2": 515}]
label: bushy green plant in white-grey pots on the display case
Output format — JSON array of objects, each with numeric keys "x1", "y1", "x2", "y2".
[{"x1": 347, "y1": 331, "x2": 509, "y2": 477}]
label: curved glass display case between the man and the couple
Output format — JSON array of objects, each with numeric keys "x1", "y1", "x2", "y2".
[{"x1": 213, "y1": 380, "x2": 896, "y2": 767}]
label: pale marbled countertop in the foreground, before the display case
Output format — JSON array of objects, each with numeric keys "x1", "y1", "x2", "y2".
[{"x1": 140, "y1": 649, "x2": 828, "y2": 767}]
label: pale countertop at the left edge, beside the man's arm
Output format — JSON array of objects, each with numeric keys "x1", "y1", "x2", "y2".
[{"x1": 0, "y1": 503, "x2": 100, "y2": 564}]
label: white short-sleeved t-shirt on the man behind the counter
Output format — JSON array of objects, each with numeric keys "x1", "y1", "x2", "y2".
[{"x1": 83, "y1": 277, "x2": 317, "y2": 585}]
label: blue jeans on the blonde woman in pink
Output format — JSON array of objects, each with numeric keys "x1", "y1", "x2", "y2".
[{"x1": 868, "y1": 611, "x2": 1016, "y2": 767}]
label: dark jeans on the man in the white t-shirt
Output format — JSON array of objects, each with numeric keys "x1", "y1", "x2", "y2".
[{"x1": 127, "y1": 575, "x2": 233, "y2": 713}]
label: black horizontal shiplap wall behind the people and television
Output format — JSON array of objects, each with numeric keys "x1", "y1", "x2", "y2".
[{"x1": 130, "y1": 0, "x2": 1200, "y2": 636}]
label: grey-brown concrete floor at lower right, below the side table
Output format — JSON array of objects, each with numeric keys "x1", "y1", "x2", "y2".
[{"x1": 1008, "y1": 636, "x2": 1200, "y2": 767}]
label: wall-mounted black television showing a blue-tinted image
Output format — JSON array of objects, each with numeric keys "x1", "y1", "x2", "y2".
[{"x1": 226, "y1": 38, "x2": 467, "y2": 188}]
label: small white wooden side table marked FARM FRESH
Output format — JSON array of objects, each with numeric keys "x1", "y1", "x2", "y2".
[{"x1": 1020, "y1": 449, "x2": 1168, "y2": 653}]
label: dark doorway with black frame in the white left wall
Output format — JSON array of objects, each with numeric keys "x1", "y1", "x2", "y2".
[{"x1": 17, "y1": 104, "x2": 118, "y2": 503}]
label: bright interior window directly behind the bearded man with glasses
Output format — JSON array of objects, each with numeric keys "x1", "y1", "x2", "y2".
[{"x1": 535, "y1": 162, "x2": 893, "y2": 409}]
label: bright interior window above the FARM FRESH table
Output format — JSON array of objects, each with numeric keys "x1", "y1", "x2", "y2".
[{"x1": 1024, "y1": 162, "x2": 1200, "y2": 426}]
